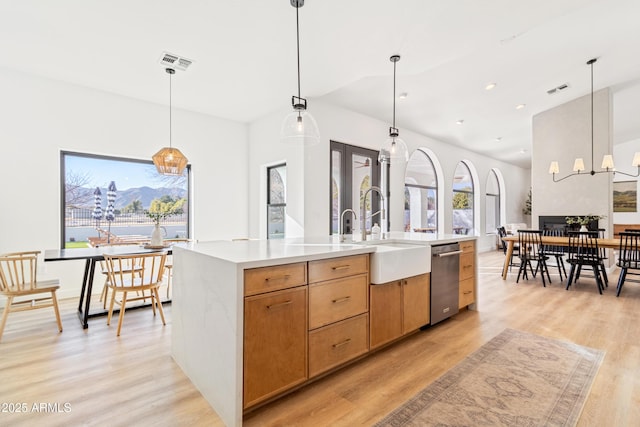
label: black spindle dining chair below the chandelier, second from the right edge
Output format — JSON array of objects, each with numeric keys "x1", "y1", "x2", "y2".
[{"x1": 566, "y1": 231, "x2": 604, "y2": 295}]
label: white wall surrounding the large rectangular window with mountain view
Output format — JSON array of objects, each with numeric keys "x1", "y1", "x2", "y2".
[{"x1": 0, "y1": 69, "x2": 248, "y2": 297}]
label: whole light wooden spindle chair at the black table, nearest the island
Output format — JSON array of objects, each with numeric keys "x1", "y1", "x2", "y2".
[{"x1": 104, "y1": 252, "x2": 167, "y2": 336}]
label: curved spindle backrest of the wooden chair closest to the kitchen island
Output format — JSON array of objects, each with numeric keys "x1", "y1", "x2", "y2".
[{"x1": 104, "y1": 252, "x2": 167, "y2": 287}]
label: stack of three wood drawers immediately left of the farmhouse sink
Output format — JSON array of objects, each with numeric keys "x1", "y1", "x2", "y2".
[{"x1": 309, "y1": 254, "x2": 369, "y2": 378}]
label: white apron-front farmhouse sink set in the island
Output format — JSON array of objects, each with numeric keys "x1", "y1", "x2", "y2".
[{"x1": 370, "y1": 242, "x2": 431, "y2": 284}]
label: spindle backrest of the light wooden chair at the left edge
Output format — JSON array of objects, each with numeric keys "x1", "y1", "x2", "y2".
[{"x1": 0, "y1": 251, "x2": 40, "y2": 293}]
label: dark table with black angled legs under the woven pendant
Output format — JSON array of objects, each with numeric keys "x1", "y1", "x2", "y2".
[{"x1": 44, "y1": 245, "x2": 176, "y2": 329}]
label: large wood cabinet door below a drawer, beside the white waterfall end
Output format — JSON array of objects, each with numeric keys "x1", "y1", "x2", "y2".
[{"x1": 242, "y1": 286, "x2": 307, "y2": 408}]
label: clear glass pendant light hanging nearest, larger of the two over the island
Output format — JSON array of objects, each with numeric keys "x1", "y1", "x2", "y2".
[{"x1": 280, "y1": 0, "x2": 320, "y2": 145}]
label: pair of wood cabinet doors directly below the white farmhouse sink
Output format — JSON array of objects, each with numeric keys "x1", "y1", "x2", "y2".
[{"x1": 369, "y1": 273, "x2": 430, "y2": 348}]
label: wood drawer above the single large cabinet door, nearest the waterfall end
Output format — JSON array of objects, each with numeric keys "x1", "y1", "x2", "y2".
[{"x1": 244, "y1": 262, "x2": 307, "y2": 296}]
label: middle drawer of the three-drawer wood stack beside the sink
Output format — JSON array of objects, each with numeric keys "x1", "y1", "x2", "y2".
[{"x1": 309, "y1": 274, "x2": 369, "y2": 329}]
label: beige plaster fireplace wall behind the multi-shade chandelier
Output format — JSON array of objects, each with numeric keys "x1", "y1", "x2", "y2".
[{"x1": 531, "y1": 88, "x2": 612, "y2": 236}]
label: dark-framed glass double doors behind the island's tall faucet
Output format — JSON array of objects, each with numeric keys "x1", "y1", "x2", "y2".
[{"x1": 329, "y1": 141, "x2": 380, "y2": 234}]
